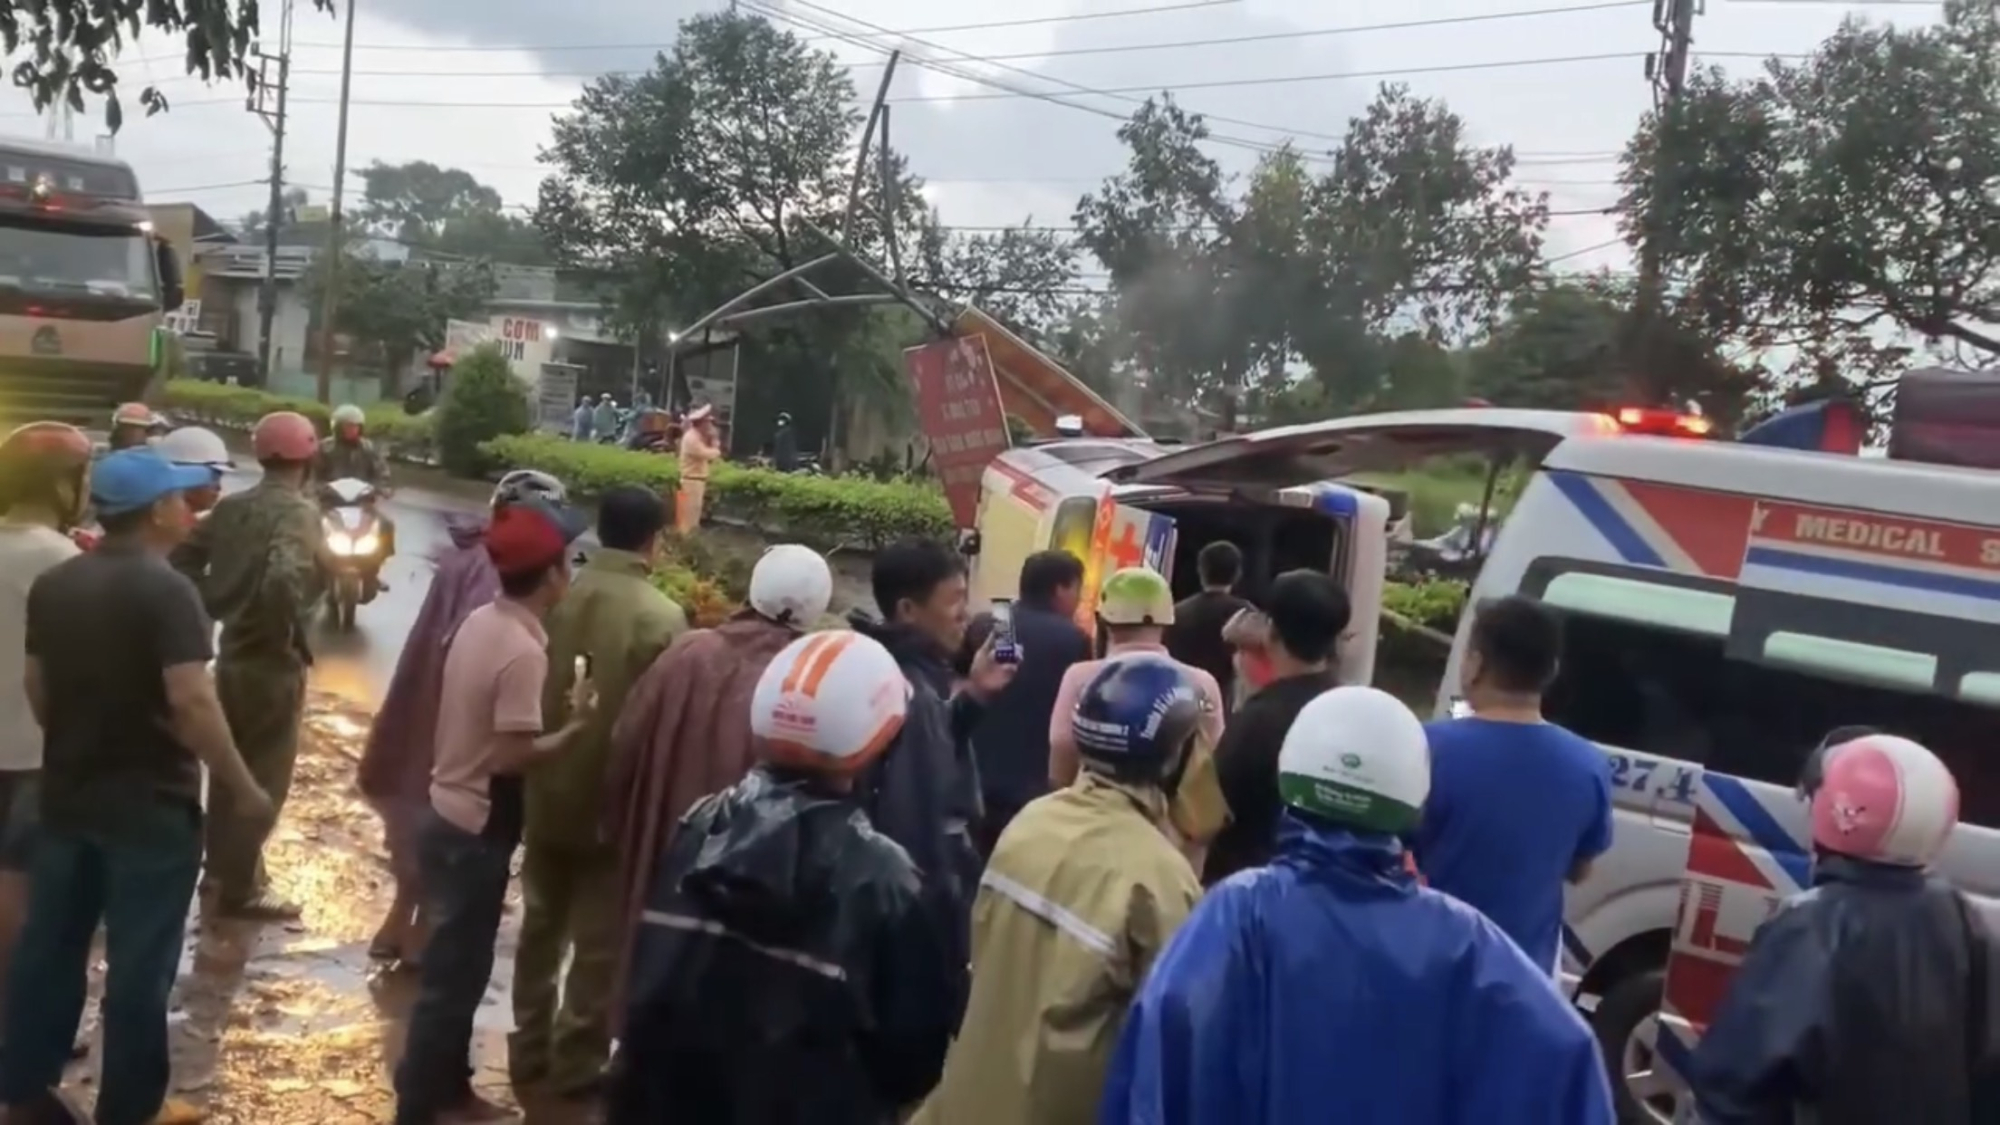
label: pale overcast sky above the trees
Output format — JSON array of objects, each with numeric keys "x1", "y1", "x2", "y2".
[{"x1": 0, "y1": 0, "x2": 1940, "y2": 268}]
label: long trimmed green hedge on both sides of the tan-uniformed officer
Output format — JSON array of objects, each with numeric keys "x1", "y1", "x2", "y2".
[{"x1": 484, "y1": 434, "x2": 952, "y2": 546}]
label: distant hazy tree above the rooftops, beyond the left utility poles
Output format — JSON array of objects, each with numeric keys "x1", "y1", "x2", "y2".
[{"x1": 356, "y1": 160, "x2": 548, "y2": 264}]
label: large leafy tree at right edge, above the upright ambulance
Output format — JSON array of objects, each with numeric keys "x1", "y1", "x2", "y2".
[{"x1": 1620, "y1": 0, "x2": 2000, "y2": 378}]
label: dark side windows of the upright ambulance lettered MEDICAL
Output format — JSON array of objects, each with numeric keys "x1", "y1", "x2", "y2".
[{"x1": 1522, "y1": 558, "x2": 2000, "y2": 827}]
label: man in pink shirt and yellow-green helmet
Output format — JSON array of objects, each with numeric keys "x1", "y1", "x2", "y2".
[{"x1": 1048, "y1": 567, "x2": 1228, "y2": 857}]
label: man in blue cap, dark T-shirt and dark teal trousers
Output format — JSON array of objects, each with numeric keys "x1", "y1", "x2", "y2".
[{"x1": 0, "y1": 446, "x2": 272, "y2": 1125}]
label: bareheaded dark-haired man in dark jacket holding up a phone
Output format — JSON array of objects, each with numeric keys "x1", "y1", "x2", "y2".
[{"x1": 850, "y1": 538, "x2": 1026, "y2": 1016}]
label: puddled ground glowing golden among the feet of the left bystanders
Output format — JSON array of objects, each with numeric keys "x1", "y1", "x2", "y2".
[{"x1": 58, "y1": 697, "x2": 552, "y2": 1125}]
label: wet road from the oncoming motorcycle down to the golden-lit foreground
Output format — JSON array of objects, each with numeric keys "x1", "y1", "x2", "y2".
[{"x1": 70, "y1": 468, "x2": 864, "y2": 1125}]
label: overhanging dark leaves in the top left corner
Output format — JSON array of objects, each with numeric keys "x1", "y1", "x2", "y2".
[{"x1": 0, "y1": 0, "x2": 334, "y2": 132}]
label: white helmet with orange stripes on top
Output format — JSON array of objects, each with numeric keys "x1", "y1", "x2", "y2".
[{"x1": 750, "y1": 629, "x2": 910, "y2": 773}]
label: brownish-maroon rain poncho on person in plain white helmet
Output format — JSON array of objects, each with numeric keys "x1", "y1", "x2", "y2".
[{"x1": 604, "y1": 611, "x2": 798, "y2": 1023}]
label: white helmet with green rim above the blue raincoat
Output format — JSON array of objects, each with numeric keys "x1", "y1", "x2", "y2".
[{"x1": 1278, "y1": 687, "x2": 1430, "y2": 835}]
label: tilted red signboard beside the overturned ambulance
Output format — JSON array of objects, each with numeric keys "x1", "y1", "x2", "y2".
[{"x1": 902, "y1": 336, "x2": 1012, "y2": 526}]
